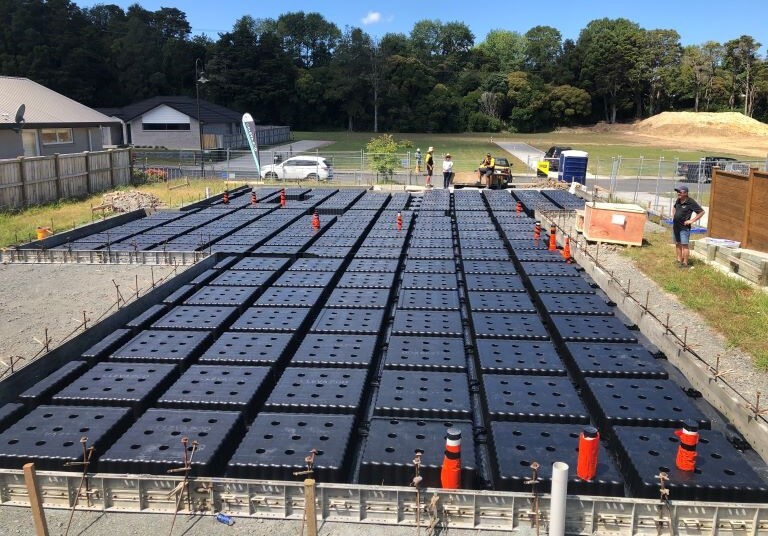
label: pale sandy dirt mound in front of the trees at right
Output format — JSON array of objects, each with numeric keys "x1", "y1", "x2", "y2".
[{"x1": 634, "y1": 112, "x2": 768, "y2": 136}]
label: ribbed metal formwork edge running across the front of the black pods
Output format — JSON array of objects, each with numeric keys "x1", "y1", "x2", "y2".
[{"x1": 0, "y1": 469, "x2": 768, "y2": 535}]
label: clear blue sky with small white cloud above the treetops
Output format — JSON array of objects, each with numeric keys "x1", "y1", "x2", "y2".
[{"x1": 74, "y1": 0, "x2": 768, "y2": 53}]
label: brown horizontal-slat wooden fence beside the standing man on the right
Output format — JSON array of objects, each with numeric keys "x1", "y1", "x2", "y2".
[{"x1": 707, "y1": 168, "x2": 768, "y2": 253}]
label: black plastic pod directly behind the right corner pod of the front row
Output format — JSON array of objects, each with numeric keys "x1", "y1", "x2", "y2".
[{"x1": 583, "y1": 378, "x2": 710, "y2": 429}]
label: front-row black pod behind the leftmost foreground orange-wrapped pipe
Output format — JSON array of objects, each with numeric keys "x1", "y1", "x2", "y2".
[{"x1": 360, "y1": 417, "x2": 479, "y2": 489}]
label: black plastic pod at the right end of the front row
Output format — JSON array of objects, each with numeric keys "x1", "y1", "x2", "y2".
[{"x1": 614, "y1": 426, "x2": 768, "y2": 503}]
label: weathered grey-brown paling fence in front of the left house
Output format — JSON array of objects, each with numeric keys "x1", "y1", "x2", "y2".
[{"x1": 0, "y1": 149, "x2": 131, "y2": 210}]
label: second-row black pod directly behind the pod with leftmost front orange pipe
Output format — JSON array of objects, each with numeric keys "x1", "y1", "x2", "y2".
[{"x1": 374, "y1": 370, "x2": 472, "y2": 420}]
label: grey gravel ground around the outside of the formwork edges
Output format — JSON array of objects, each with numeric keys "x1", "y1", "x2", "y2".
[{"x1": 0, "y1": 224, "x2": 768, "y2": 536}]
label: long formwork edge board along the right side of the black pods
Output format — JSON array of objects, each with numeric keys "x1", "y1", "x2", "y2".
[{"x1": 573, "y1": 250, "x2": 768, "y2": 460}]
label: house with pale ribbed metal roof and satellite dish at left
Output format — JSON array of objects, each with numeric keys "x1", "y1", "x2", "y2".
[{"x1": 0, "y1": 76, "x2": 120, "y2": 159}]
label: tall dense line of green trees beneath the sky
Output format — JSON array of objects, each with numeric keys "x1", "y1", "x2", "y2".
[{"x1": 0, "y1": 0, "x2": 768, "y2": 132}]
